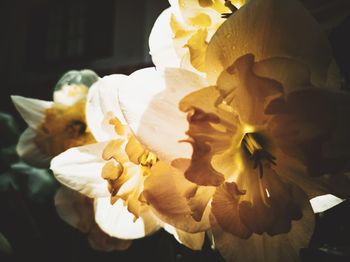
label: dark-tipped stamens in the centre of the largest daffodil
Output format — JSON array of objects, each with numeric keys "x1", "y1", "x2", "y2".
[{"x1": 242, "y1": 133, "x2": 276, "y2": 178}]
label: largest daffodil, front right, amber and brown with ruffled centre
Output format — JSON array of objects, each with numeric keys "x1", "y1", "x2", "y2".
[{"x1": 119, "y1": 0, "x2": 350, "y2": 261}]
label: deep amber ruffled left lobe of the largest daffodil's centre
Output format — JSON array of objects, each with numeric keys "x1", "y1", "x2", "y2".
[{"x1": 180, "y1": 87, "x2": 241, "y2": 186}]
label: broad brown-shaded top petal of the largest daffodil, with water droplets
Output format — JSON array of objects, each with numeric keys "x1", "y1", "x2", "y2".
[{"x1": 206, "y1": 0, "x2": 332, "y2": 86}]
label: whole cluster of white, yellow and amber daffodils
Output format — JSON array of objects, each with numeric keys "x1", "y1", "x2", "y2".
[{"x1": 13, "y1": 0, "x2": 350, "y2": 261}]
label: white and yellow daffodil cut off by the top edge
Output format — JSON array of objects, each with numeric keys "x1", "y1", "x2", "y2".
[{"x1": 149, "y1": 0, "x2": 247, "y2": 72}]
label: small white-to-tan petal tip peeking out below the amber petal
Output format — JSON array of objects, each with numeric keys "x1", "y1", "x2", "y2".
[{"x1": 164, "y1": 224, "x2": 205, "y2": 250}]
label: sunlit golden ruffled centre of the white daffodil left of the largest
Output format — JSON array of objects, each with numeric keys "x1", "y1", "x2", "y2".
[{"x1": 101, "y1": 114, "x2": 158, "y2": 205}]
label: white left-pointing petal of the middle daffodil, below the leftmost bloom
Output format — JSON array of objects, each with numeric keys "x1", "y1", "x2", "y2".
[{"x1": 50, "y1": 142, "x2": 109, "y2": 198}]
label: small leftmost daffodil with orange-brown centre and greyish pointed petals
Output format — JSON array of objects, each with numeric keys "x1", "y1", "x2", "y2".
[{"x1": 11, "y1": 70, "x2": 98, "y2": 167}]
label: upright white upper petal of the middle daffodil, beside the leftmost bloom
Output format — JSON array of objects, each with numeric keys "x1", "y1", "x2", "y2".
[{"x1": 86, "y1": 75, "x2": 127, "y2": 141}]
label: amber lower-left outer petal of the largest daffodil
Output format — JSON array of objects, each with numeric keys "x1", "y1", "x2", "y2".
[{"x1": 143, "y1": 162, "x2": 209, "y2": 233}]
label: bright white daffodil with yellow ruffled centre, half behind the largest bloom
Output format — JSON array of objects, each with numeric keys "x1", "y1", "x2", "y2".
[{"x1": 51, "y1": 74, "x2": 204, "y2": 250}]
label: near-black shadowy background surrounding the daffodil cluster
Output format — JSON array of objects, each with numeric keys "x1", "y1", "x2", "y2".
[{"x1": 0, "y1": 0, "x2": 350, "y2": 262}]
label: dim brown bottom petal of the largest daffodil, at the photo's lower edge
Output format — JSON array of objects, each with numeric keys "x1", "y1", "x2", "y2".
[{"x1": 211, "y1": 199, "x2": 314, "y2": 262}]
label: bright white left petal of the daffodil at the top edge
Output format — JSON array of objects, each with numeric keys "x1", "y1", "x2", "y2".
[{"x1": 148, "y1": 8, "x2": 180, "y2": 68}]
